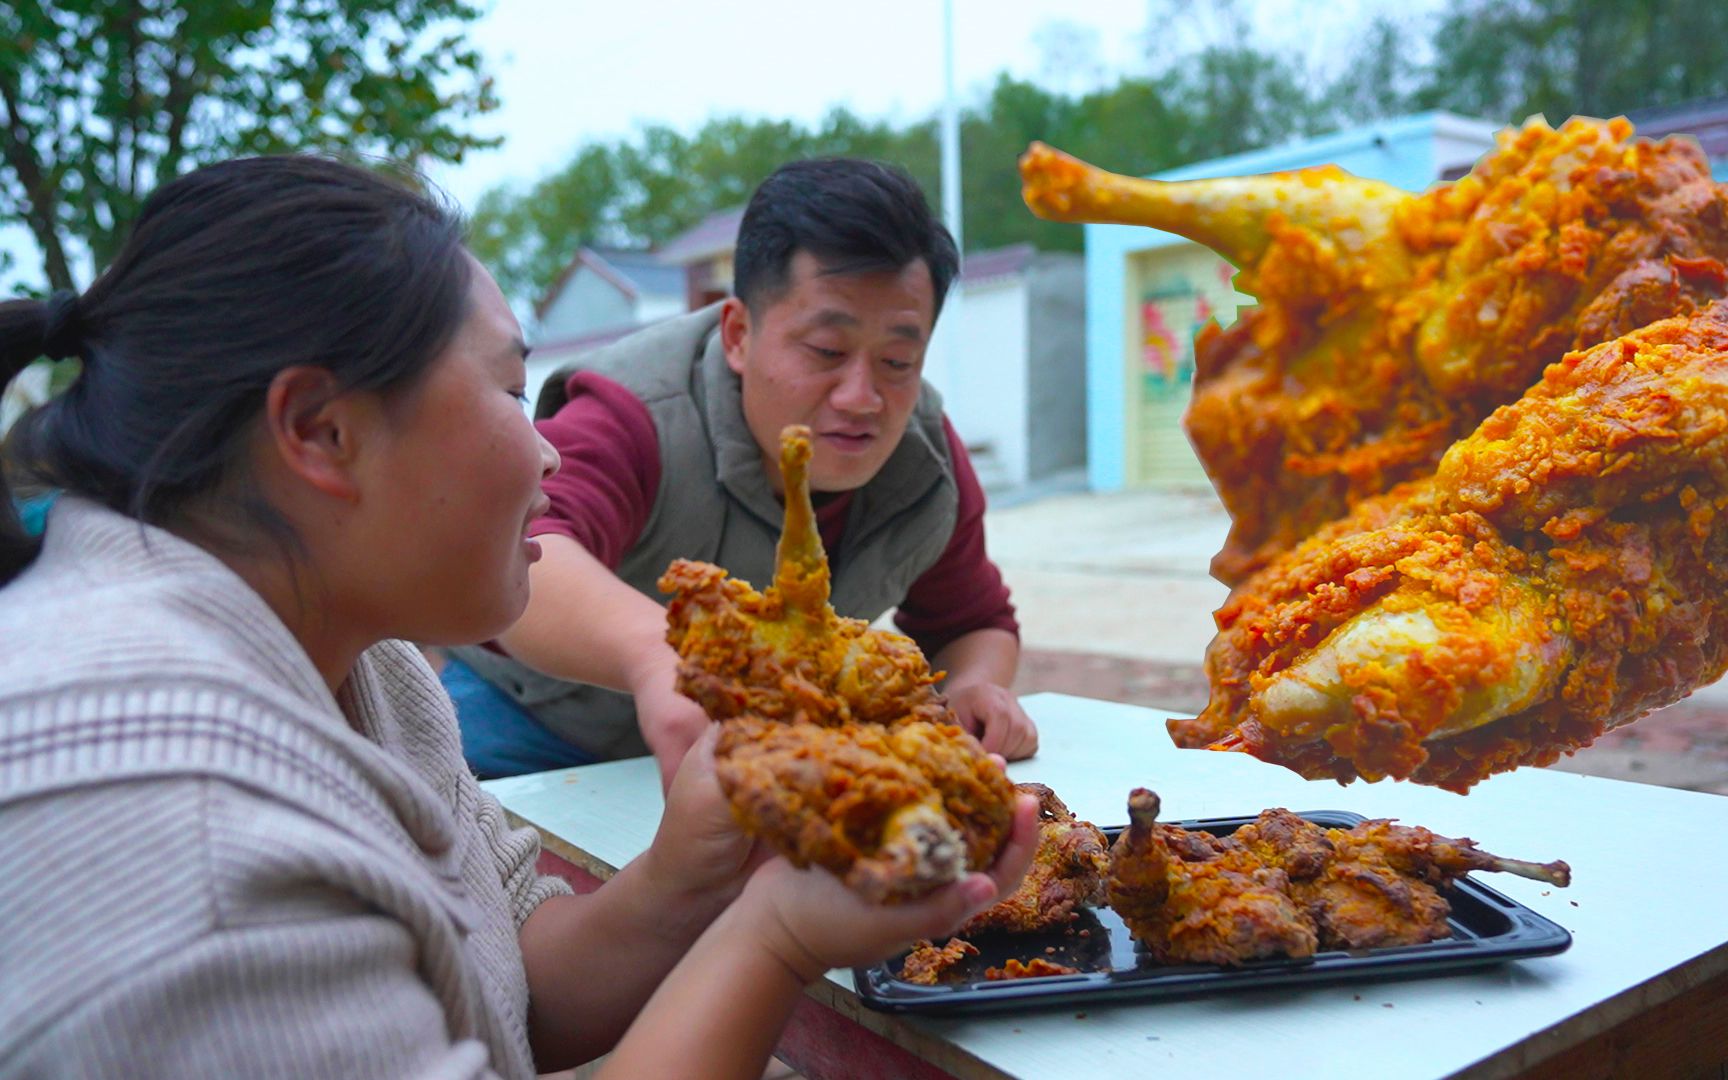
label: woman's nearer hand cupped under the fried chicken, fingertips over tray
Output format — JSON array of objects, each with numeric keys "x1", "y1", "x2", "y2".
[{"x1": 727, "y1": 795, "x2": 1039, "y2": 982}]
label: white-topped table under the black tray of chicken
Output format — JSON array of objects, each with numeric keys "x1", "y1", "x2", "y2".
[{"x1": 486, "y1": 695, "x2": 1728, "y2": 1080}]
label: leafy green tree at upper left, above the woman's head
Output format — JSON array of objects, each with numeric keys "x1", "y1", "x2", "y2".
[{"x1": 0, "y1": 0, "x2": 496, "y2": 289}]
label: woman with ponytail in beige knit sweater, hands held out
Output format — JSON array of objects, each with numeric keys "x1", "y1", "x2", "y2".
[{"x1": 0, "y1": 157, "x2": 1032, "y2": 1078}]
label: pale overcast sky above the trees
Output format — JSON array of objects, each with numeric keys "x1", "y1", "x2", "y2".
[{"x1": 0, "y1": 0, "x2": 1443, "y2": 292}]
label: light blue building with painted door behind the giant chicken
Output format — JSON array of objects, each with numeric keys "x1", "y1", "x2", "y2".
[{"x1": 1085, "y1": 112, "x2": 1495, "y2": 491}]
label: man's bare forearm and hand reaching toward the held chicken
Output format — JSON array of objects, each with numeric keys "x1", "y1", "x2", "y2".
[{"x1": 498, "y1": 532, "x2": 708, "y2": 786}]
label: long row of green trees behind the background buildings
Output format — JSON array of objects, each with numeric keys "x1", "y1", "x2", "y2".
[{"x1": 475, "y1": 0, "x2": 1728, "y2": 309}]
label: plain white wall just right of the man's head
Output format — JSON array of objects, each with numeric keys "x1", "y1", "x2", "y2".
[{"x1": 937, "y1": 276, "x2": 1028, "y2": 486}]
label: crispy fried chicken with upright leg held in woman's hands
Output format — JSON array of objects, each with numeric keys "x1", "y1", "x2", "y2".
[{"x1": 660, "y1": 427, "x2": 1016, "y2": 904}]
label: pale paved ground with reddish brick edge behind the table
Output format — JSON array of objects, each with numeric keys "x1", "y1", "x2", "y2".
[{"x1": 985, "y1": 491, "x2": 1728, "y2": 795}]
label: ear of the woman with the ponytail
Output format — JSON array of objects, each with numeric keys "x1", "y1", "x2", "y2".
[{"x1": 263, "y1": 365, "x2": 363, "y2": 503}]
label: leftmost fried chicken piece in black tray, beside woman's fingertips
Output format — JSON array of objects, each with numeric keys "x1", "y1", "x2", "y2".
[{"x1": 959, "y1": 785, "x2": 1109, "y2": 937}]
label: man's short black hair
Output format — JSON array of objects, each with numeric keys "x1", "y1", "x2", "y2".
[{"x1": 733, "y1": 157, "x2": 961, "y2": 313}]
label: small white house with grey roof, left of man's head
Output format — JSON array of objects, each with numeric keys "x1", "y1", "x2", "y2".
[{"x1": 527, "y1": 247, "x2": 688, "y2": 401}]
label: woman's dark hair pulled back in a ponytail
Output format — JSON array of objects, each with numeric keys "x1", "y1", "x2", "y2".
[{"x1": 0, "y1": 157, "x2": 470, "y2": 584}]
